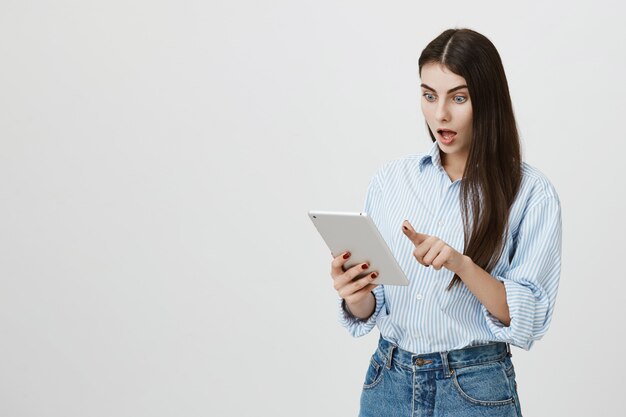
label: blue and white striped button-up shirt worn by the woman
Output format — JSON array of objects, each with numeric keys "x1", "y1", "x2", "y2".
[{"x1": 338, "y1": 142, "x2": 561, "y2": 354}]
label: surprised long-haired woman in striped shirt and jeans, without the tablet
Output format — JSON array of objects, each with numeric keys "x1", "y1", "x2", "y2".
[{"x1": 331, "y1": 29, "x2": 561, "y2": 417}]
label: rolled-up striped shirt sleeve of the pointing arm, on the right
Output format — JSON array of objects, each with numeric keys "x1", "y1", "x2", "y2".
[{"x1": 481, "y1": 196, "x2": 561, "y2": 350}]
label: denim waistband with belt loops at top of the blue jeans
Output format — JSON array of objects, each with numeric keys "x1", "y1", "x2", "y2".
[{"x1": 378, "y1": 336, "x2": 512, "y2": 374}]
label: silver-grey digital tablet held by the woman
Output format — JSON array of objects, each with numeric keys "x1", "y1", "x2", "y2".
[{"x1": 308, "y1": 211, "x2": 409, "y2": 285}]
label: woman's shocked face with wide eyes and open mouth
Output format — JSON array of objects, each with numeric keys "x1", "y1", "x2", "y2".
[{"x1": 421, "y1": 63, "x2": 472, "y2": 161}]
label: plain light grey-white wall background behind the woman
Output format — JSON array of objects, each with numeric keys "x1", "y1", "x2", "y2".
[{"x1": 0, "y1": 0, "x2": 626, "y2": 417}]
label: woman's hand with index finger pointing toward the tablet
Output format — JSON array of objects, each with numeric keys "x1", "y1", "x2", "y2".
[{"x1": 402, "y1": 220, "x2": 467, "y2": 274}]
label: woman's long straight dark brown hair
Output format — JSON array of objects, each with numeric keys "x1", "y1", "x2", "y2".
[{"x1": 418, "y1": 28, "x2": 522, "y2": 290}]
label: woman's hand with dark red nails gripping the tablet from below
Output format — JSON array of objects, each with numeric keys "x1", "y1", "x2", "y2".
[{"x1": 330, "y1": 252, "x2": 378, "y2": 319}]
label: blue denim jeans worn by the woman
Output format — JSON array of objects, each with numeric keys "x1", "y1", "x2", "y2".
[{"x1": 359, "y1": 336, "x2": 522, "y2": 417}]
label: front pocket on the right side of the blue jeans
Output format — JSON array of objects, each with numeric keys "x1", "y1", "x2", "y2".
[{"x1": 452, "y1": 360, "x2": 515, "y2": 406}]
